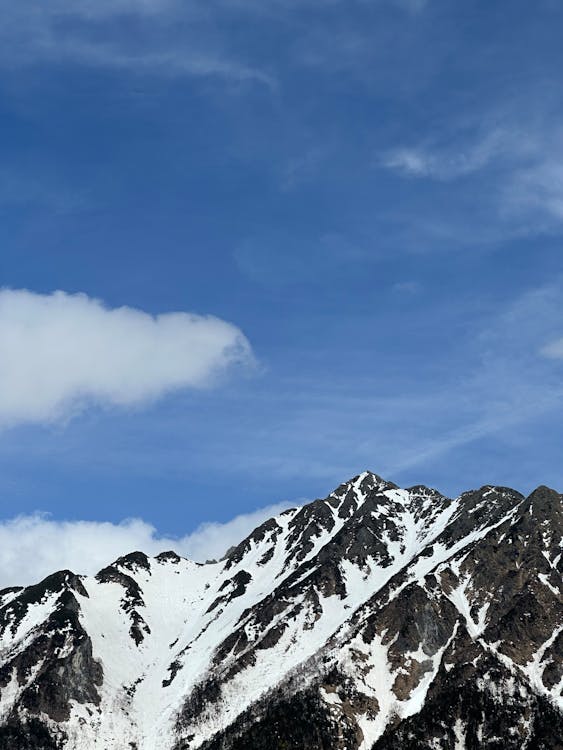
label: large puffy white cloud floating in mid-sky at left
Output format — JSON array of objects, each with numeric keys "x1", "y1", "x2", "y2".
[{"x1": 0, "y1": 289, "x2": 252, "y2": 427}]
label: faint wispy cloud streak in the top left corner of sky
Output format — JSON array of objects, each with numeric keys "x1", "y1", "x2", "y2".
[{"x1": 0, "y1": 0, "x2": 275, "y2": 87}]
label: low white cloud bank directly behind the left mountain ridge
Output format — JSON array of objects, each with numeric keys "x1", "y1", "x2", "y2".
[{"x1": 0, "y1": 503, "x2": 291, "y2": 589}]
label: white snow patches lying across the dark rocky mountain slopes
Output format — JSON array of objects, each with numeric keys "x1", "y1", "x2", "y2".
[{"x1": 0, "y1": 472, "x2": 557, "y2": 750}]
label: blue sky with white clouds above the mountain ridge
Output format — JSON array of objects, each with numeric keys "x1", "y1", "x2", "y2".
[{"x1": 0, "y1": 0, "x2": 563, "y2": 585}]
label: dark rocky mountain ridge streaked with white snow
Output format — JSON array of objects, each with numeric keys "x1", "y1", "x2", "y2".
[{"x1": 0, "y1": 472, "x2": 563, "y2": 750}]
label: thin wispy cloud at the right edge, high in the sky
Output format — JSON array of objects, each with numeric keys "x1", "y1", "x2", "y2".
[{"x1": 382, "y1": 112, "x2": 563, "y2": 245}]
